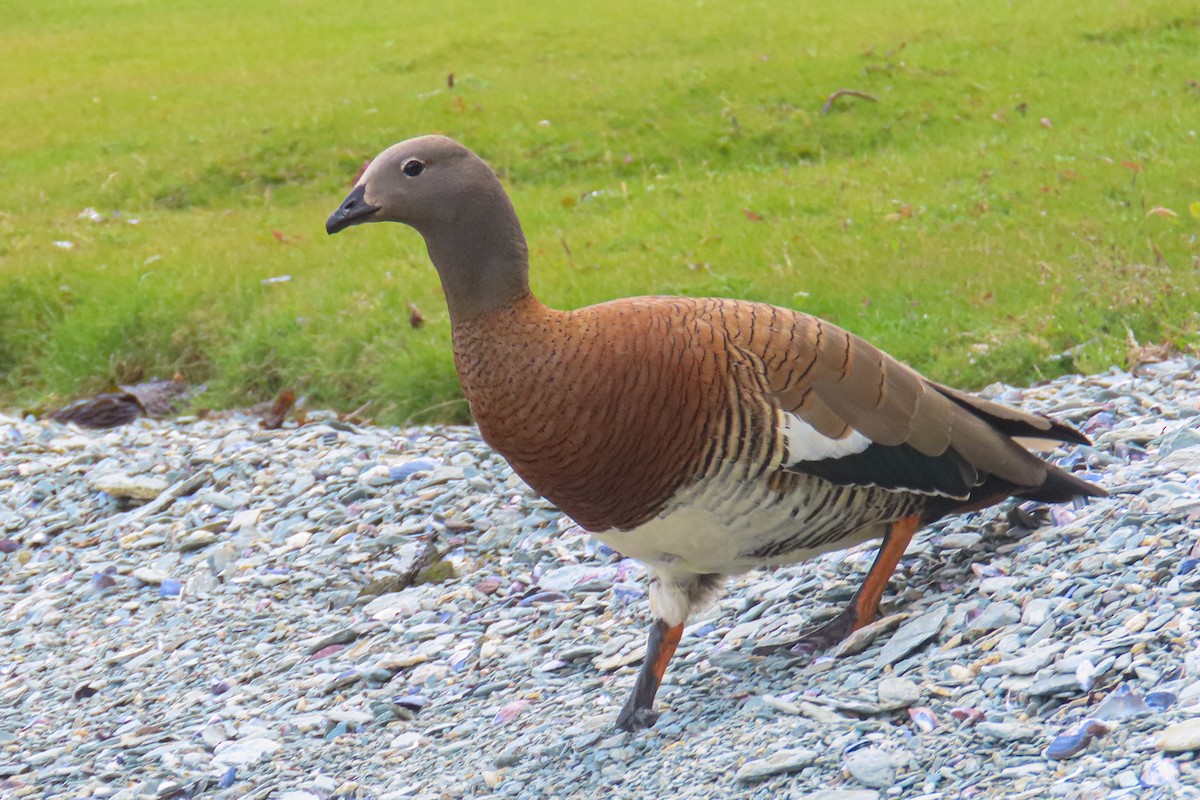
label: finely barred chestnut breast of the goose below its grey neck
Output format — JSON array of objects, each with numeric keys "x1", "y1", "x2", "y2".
[{"x1": 454, "y1": 296, "x2": 758, "y2": 530}]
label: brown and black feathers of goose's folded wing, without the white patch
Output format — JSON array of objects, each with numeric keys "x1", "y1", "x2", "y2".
[{"x1": 728, "y1": 303, "x2": 1086, "y2": 498}]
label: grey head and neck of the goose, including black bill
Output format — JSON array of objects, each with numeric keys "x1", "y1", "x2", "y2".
[{"x1": 325, "y1": 136, "x2": 529, "y2": 324}]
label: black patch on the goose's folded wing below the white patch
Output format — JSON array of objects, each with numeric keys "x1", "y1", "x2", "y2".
[{"x1": 787, "y1": 444, "x2": 984, "y2": 499}]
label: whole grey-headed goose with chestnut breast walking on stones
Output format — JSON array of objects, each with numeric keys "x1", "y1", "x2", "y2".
[{"x1": 325, "y1": 136, "x2": 1105, "y2": 730}]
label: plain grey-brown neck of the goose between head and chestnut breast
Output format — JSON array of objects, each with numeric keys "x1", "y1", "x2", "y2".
[{"x1": 422, "y1": 181, "x2": 529, "y2": 325}]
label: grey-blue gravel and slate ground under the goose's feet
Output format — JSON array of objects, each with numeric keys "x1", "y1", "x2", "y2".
[{"x1": 0, "y1": 359, "x2": 1200, "y2": 800}]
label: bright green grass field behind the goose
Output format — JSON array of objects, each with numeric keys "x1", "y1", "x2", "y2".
[{"x1": 0, "y1": 0, "x2": 1200, "y2": 422}]
